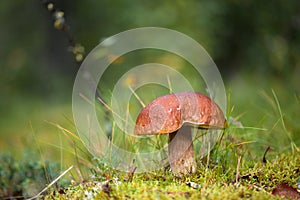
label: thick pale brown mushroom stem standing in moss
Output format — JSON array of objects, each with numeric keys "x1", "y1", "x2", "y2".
[{"x1": 168, "y1": 126, "x2": 196, "y2": 175}]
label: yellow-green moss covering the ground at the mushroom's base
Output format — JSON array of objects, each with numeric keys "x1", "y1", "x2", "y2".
[{"x1": 45, "y1": 154, "x2": 300, "y2": 199}]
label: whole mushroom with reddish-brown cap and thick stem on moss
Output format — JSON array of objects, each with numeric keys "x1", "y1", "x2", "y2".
[{"x1": 134, "y1": 92, "x2": 227, "y2": 175}]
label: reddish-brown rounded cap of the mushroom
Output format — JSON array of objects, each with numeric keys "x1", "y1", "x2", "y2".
[{"x1": 134, "y1": 92, "x2": 226, "y2": 135}]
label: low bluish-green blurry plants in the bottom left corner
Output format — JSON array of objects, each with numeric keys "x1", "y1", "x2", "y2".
[{"x1": 0, "y1": 153, "x2": 64, "y2": 198}]
